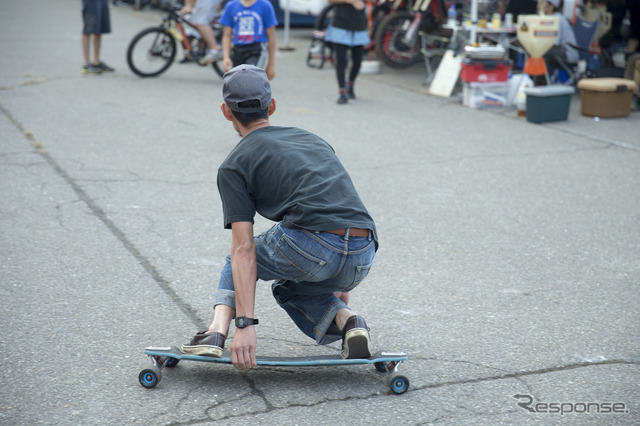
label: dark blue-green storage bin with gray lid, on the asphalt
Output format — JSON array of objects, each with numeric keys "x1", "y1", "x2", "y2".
[{"x1": 524, "y1": 85, "x2": 575, "y2": 123}]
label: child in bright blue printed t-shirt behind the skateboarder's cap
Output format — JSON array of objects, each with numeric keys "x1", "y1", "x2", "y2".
[{"x1": 220, "y1": 0, "x2": 278, "y2": 80}]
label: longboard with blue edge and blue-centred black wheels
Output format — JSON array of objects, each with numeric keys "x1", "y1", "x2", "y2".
[{"x1": 138, "y1": 346, "x2": 409, "y2": 394}]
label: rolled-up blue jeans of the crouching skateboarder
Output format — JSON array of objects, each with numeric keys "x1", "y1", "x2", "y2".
[{"x1": 214, "y1": 224, "x2": 375, "y2": 345}]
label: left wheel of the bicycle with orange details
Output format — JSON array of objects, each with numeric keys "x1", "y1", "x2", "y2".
[{"x1": 127, "y1": 27, "x2": 177, "y2": 77}]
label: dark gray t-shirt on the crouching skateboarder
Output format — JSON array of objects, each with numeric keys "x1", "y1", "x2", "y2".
[{"x1": 218, "y1": 126, "x2": 377, "y2": 242}]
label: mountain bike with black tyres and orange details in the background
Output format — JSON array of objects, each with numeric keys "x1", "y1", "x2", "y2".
[{"x1": 127, "y1": 2, "x2": 224, "y2": 77}]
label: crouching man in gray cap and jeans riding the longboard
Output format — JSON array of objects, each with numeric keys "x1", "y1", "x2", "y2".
[{"x1": 181, "y1": 65, "x2": 378, "y2": 369}]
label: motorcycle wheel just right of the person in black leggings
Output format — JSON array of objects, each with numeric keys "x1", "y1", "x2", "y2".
[{"x1": 375, "y1": 10, "x2": 420, "y2": 68}]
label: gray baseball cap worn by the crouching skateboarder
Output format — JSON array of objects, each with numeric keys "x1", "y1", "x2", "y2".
[{"x1": 222, "y1": 64, "x2": 271, "y2": 113}]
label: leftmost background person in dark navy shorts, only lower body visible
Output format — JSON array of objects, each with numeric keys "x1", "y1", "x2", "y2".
[{"x1": 82, "y1": 0, "x2": 114, "y2": 74}]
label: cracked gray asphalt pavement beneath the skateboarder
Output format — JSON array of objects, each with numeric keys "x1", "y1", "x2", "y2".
[{"x1": 0, "y1": 0, "x2": 640, "y2": 425}]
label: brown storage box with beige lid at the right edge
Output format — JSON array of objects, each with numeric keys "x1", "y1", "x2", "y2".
[{"x1": 578, "y1": 78, "x2": 638, "y2": 118}]
